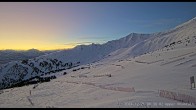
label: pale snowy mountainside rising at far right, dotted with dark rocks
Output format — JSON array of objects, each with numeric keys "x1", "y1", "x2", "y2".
[{"x1": 130, "y1": 18, "x2": 196, "y2": 56}]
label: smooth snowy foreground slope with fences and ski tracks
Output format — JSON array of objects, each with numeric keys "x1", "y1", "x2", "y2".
[{"x1": 0, "y1": 42, "x2": 196, "y2": 108}]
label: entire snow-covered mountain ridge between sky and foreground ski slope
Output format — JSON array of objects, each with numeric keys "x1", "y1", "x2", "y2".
[{"x1": 0, "y1": 18, "x2": 196, "y2": 88}]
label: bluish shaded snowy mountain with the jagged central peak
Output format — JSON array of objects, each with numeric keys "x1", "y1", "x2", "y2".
[{"x1": 47, "y1": 33, "x2": 150, "y2": 64}]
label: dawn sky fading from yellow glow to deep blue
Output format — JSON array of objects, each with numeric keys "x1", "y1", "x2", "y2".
[{"x1": 0, "y1": 2, "x2": 196, "y2": 50}]
